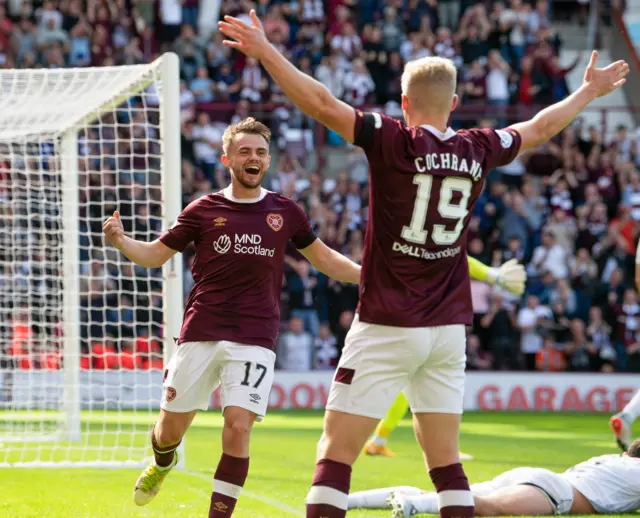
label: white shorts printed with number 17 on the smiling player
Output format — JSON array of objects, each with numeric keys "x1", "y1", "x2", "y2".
[{"x1": 160, "y1": 341, "x2": 276, "y2": 421}]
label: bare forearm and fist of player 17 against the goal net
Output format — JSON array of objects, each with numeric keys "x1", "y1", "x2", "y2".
[{"x1": 102, "y1": 211, "x2": 176, "y2": 268}]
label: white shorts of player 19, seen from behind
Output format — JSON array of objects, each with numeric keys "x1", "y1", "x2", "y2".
[{"x1": 327, "y1": 316, "x2": 466, "y2": 419}]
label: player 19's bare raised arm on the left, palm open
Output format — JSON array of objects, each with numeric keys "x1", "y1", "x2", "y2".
[{"x1": 218, "y1": 9, "x2": 356, "y2": 142}]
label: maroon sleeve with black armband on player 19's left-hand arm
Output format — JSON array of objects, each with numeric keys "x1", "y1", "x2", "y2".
[{"x1": 353, "y1": 110, "x2": 406, "y2": 168}]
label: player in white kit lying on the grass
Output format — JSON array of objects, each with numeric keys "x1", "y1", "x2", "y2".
[{"x1": 349, "y1": 439, "x2": 640, "y2": 518}]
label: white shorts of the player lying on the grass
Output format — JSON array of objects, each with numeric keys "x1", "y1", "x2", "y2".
[{"x1": 471, "y1": 468, "x2": 573, "y2": 514}]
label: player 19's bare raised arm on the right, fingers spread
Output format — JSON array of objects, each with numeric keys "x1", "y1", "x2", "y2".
[{"x1": 511, "y1": 50, "x2": 629, "y2": 151}]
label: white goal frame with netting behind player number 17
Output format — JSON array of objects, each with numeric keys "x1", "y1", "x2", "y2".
[{"x1": 0, "y1": 53, "x2": 182, "y2": 467}]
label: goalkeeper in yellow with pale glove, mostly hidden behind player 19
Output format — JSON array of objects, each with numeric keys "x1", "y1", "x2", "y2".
[{"x1": 364, "y1": 256, "x2": 527, "y2": 460}]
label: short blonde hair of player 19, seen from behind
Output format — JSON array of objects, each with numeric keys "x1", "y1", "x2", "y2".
[{"x1": 401, "y1": 57, "x2": 458, "y2": 112}]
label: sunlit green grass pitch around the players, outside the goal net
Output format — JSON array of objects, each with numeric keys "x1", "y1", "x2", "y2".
[{"x1": 0, "y1": 411, "x2": 636, "y2": 518}]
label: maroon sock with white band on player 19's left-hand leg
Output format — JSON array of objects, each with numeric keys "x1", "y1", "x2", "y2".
[{"x1": 307, "y1": 459, "x2": 351, "y2": 518}]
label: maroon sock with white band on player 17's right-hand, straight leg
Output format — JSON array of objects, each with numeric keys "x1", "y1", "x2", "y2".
[{"x1": 209, "y1": 453, "x2": 249, "y2": 518}]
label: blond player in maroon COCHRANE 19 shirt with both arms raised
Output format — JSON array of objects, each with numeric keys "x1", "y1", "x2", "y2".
[{"x1": 219, "y1": 10, "x2": 629, "y2": 518}]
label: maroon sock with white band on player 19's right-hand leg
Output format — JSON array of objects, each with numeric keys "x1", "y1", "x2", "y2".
[{"x1": 429, "y1": 463, "x2": 475, "y2": 518}]
